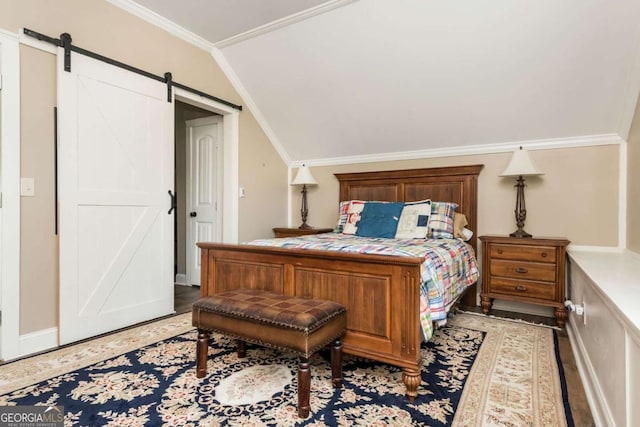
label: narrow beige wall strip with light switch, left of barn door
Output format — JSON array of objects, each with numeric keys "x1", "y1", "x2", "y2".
[{"x1": 20, "y1": 47, "x2": 58, "y2": 334}]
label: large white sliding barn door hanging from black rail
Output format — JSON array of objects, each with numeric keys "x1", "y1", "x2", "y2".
[{"x1": 58, "y1": 49, "x2": 175, "y2": 344}]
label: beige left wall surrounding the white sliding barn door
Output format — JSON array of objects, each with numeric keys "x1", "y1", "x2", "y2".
[{"x1": 0, "y1": 0, "x2": 288, "y2": 334}]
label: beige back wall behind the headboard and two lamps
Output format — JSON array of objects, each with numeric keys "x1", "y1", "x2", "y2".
[{"x1": 298, "y1": 145, "x2": 619, "y2": 246}]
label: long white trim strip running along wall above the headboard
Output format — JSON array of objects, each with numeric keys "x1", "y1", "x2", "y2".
[{"x1": 290, "y1": 134, "x2": 624, "y2": 167}]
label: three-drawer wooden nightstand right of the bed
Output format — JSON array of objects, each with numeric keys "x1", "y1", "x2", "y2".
[{"x1": 479, "y1": 236, "x2": 569, "y2": 328}]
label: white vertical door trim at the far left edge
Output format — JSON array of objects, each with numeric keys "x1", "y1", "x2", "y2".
[{"x1": 0, "y1": 30, "x2": 20, "y2": 360}]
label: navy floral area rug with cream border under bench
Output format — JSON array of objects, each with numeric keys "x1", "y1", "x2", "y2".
[{"x1": 0, "y1": 314, "x2": 572, "y2": 426}]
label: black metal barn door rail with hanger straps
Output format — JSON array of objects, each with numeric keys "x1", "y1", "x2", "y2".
[{"x1": 23, "y1": 28, "x2": 242, "y2": 111}]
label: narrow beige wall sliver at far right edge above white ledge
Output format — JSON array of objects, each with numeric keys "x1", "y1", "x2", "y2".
[{"x1": 627, "y1": 98, "x2": 640, "y2": 253}]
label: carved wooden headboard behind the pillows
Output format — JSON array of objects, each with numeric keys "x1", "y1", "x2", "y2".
[{"x1": 335, "y1": 165, "x2": 484, "y2": 253}]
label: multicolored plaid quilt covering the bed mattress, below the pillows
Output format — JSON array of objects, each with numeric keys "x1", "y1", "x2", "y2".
[{"x1": 246, "y1": 233, "x2": 480, "y2": 341}]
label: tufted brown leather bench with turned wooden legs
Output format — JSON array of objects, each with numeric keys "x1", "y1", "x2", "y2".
[{"x1": 192, "y1": 289, "x2": 347, "y2": 418}]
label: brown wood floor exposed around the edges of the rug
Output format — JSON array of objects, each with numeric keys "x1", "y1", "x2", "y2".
[{"x1": 175, "y1": 285, "x2": 595, "y2": 427}]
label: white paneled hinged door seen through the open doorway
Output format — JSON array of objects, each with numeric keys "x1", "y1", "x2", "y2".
[{"x1": 186, "y1": 116, "x2": 223, "y2": 285}]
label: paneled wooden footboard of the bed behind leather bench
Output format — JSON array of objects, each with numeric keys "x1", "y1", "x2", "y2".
[{"x1": 198, "y1": 243, "x2": 422, "y2": 400}]
